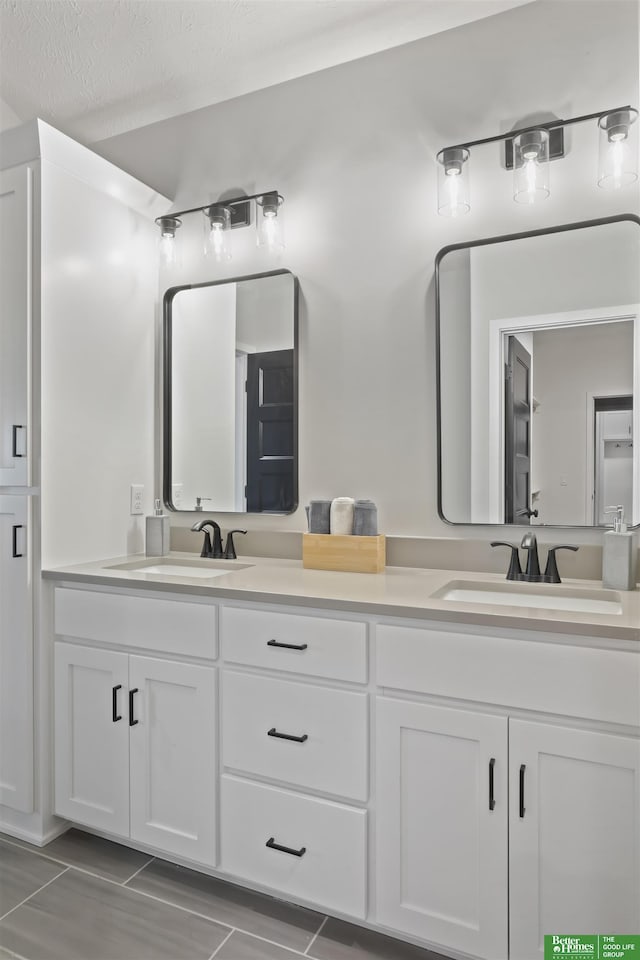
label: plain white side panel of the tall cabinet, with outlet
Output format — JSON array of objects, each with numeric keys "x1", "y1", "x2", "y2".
[{"x1": 42, "y1": 160, "x2": 157, "y2": 567}]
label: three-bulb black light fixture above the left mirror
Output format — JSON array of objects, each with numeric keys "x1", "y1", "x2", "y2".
[{"x1": 156, "y1": 190, "x2": 284, "y2": 265}]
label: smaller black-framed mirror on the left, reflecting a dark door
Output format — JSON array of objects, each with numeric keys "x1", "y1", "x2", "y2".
[{"x1": 164, "y1": 270, "x2": 298, "y2": 513}]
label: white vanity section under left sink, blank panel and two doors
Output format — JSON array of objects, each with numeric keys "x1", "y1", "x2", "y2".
[{"x1": 54, "y1": 588, "x2": 217, "y2": 866}]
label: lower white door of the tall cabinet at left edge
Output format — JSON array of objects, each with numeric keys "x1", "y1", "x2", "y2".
[{"x1": 0, "y1": 497, "x2": 33, "y2": 813}]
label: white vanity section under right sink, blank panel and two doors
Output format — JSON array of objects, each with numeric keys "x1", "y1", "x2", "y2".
[{"x1": 376, "y1": 625, "x2": 640, "y2": 960}]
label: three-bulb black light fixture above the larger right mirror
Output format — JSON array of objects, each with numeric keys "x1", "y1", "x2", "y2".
[{"x1": 436, "y1": 106, "x2": 638, "y2": 217}]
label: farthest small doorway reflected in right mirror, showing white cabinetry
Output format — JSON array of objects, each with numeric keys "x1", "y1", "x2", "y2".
[{"x1": 593, "y1": 396, "x2": 633, "y2": 526}]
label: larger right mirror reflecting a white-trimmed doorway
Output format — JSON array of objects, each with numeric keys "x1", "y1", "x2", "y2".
[{"x1": 436, "y1": 215, "x2": 640, "y2": 526}]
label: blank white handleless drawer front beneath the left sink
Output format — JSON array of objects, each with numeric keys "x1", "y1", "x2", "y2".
[{"x1": 54, "y1": 587, "x2": 217, "y2": 659}]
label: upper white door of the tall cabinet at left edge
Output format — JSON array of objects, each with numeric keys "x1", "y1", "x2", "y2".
[{"x1": 0, "y1": 167, "x2": 32, "y2": 486}]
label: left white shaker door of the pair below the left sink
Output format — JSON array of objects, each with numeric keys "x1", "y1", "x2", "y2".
[{"x1": 54, "y1": 641, "x2": 129, "y2": 837}]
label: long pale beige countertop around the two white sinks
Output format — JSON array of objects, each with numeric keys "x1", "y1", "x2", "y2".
[{"x1": 42, "y1": 552, "x2": 640, "y2": 641}]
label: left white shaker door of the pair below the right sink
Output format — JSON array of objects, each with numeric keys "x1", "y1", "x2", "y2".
[{"x1": 376, "y1": 698, "x2": 508, "y2": 960}]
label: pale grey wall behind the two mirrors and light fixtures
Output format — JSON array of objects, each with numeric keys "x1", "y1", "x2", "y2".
[{"x1": 97, "y1": 0, "x2": 639, "y2": 536}]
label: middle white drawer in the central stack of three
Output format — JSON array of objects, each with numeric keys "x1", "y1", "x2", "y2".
[{"x1": 222, "y1": 670, "x2": 368, "y2": 800}]
